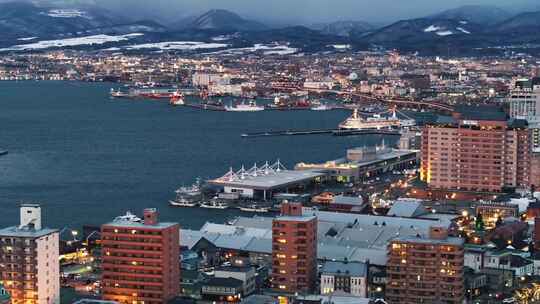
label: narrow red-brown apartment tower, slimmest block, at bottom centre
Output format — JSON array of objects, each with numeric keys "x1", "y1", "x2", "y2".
[{"x1": 272, "y1": 202, "x2": 317, "y2": 293}]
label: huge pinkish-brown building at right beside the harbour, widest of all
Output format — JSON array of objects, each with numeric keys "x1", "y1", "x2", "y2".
[{"x1": 420, "y1": 107, "x2": 532, "y2": 192}]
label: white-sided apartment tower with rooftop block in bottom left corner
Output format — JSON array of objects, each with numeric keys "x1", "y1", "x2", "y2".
[{"x1": 0, "y1": 204, "x2": 60, "y2": 304}]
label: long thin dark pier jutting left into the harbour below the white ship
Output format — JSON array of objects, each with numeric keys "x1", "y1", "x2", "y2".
[{"x1": 241, "y1": 129, "x2": 400, "y2": 138}]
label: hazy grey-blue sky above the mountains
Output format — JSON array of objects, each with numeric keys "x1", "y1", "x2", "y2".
[{"x1": 30, "y1": 0, "x2": 540, "y2": 24}]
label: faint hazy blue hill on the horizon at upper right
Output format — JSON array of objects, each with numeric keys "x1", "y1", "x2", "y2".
[{"x1": 427, "y1": 5, "x2": 512, "y2": 25}]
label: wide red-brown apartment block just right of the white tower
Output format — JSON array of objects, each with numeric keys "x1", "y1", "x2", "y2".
[{"x1": 101, "y1": 209, "x2": 180, "y2": 304}]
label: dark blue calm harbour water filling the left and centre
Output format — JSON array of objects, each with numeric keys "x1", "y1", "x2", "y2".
[{"x1": 0, "y1": 82, "x2": 395, "y2": 231}]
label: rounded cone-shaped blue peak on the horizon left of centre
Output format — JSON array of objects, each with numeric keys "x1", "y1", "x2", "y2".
[{"x1": 171, "y1": 9, "x2": 268, "y2": 31}]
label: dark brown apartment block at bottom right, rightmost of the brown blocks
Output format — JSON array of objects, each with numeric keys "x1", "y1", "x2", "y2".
[{"x1": 385, "y1": 227, "x2": 464, "y2": 304}]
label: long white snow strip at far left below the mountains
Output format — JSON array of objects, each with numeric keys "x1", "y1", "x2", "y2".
[{"x1": 0, "y1": 33, "x2": 144, "y2": 52}]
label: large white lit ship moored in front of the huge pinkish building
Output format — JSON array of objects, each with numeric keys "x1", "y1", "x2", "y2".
[{"x1": 339, "y1": 109, "x2": 416, "y2": 130}]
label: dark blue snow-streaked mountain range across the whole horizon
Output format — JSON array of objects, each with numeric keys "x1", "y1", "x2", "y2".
[{"x1": 0, "y1": 1, "x2": 540, "y2": 53}]
